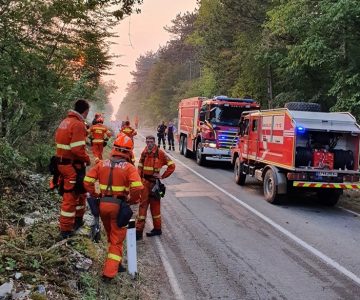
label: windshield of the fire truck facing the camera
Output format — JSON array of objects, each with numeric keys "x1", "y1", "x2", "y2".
[{"x1": 209, "y1": 105, "x2": 248, "y2": 126}]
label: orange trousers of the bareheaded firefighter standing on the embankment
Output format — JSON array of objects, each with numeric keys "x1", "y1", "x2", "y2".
[{"x1": 58, "y1": 165, "x2": 86, "y2": 231}]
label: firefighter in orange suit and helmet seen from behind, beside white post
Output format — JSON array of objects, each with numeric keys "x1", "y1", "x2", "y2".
[{"x1": 84, "y1": 135, "x2": 144, "y2": 280}]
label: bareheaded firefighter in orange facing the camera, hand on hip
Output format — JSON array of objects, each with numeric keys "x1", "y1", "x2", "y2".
[{"x1": 136, "y1": 135, "x2": 175, "y2": 240}]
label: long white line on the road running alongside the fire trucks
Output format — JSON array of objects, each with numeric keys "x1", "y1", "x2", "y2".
[{"x1": 168, "y1": 153, "x2": 360, "y2": 285}]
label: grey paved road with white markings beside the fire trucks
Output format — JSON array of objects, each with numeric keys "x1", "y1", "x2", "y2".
[{"x1": 131, "y1": 132, "x2": 360, "y2": 299}]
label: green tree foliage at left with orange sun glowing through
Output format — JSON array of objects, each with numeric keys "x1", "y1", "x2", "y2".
[{"x1": 0, "y1": 0, "x2": 142, "y2": 172}]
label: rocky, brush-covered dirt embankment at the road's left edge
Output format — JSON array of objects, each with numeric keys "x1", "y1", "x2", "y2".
[{"x1": 0, "y1": 174, "x2": 163, "y2": 300}]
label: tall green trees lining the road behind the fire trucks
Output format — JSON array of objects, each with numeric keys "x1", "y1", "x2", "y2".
[{"x1": 118, "y1": 0, "x2": 360, "y2": 125}]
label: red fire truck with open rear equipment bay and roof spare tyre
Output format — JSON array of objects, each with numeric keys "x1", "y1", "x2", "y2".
[{"x1": 231, "y1": 102, "x2": 360, "y2": 205}]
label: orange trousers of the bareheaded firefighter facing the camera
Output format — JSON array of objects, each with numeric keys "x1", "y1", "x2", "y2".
[{"x1": 136, "y1": 179, "x2": 161, "y2": 232}]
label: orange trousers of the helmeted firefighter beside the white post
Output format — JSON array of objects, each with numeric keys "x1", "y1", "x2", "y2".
[{"x1": 100, "y1": 202, "x2": 126, "y2": 278}]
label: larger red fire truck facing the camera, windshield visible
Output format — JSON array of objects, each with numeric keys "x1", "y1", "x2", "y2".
[{"x1": 178, "y1": 96, "x2": 260, "y2": 165}]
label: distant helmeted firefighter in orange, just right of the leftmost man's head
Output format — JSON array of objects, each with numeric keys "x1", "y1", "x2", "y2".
[{"x1": 89, "y1": 117, "x2": 111, "y2": 163}]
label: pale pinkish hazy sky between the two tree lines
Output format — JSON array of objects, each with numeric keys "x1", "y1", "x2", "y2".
[{"x1": 105, "y1": 0, "x2": 197, "y2": 118}]
